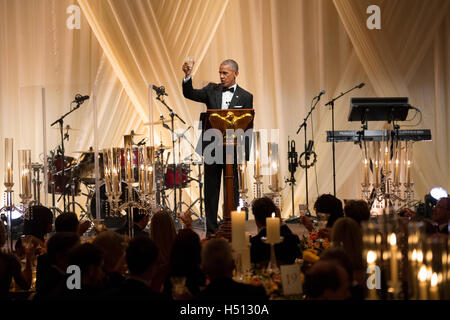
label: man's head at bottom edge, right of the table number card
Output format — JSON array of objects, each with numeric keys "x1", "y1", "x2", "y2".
[{"x1": 303, "y1": 260, "x2": 351, "y2": 300}]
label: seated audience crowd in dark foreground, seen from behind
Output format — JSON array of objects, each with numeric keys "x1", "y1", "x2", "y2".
[{"x1": 0, "y1": 194, "x2": 450, "y2": 301}]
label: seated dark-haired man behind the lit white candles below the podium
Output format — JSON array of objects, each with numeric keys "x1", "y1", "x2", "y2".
[{"x1": 250, "y1": 197, "x2": 301, "y2": 264}]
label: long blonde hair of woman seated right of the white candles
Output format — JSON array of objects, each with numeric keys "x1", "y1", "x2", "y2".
[{"x1": 331, "y1": 217, "x2": 363, "y2": 270}]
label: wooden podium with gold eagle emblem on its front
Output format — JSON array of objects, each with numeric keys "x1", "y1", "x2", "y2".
[{"x1": 205, "y1": 109, "x2": 255, "y2": 241}]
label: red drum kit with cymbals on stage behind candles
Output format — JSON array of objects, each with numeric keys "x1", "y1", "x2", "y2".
[{"x1": 32, "y1": 119, "x2": 203, "y2": 229}]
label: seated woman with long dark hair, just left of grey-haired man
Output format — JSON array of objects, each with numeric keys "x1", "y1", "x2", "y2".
[{"x1": 163, "y1": 229, "x2": 206, "y2": 300}]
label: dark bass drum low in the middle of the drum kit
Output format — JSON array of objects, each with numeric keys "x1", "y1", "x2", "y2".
[{"x1": 90, "y1": 182, "x2": 139, "y2": 233}]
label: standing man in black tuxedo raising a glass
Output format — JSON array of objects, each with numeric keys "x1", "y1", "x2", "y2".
[{"x1": 182, "y1": 59, "x2": 253, "y2": 237}]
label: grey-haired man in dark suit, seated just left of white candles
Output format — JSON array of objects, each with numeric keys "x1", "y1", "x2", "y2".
[{"x1": 197, "y1": 239, "x2": 267, "y2": 302}]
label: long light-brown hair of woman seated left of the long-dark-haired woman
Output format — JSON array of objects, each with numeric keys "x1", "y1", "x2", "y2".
[{"x1": 150, "y1": 210, "x2": 177, "y2": 266}]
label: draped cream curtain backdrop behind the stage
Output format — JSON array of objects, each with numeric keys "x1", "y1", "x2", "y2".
[{"x1": 0, "y1": 0, "x2": 450, "y2": 216}]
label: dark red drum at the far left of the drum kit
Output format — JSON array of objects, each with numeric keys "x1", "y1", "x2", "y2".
[{"x1": 48, "y1": 155, "x2": 81, "y2": 196}]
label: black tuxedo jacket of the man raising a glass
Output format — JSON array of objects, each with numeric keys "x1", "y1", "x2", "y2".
[{"x1": 183, "y1": 78, "x2": 253, "y2": 161}]
